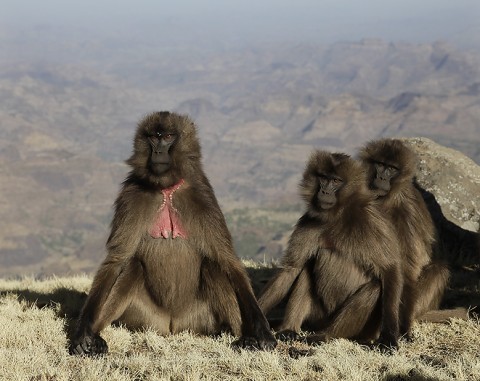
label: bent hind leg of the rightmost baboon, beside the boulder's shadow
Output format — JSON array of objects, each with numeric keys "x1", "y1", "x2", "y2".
[{"x1": 415, "y1": 262, "x2": 450, "y2": 317}]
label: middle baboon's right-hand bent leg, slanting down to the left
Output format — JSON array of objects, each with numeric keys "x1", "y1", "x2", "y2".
[{"x1": 307, "y1": 281, "x2": 381, "y2": 344}]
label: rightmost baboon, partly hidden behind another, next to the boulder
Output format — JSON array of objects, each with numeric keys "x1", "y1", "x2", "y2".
[{"x1": 359, "y1": 139, "x2": 449, "y2": 338}]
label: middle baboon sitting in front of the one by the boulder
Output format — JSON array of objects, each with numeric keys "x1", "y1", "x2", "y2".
[{"x1": 259, "y1": 151, "x2": 403, "y2": 348}]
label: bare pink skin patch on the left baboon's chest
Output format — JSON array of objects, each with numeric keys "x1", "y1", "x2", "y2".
[{"x1": 148, "y1": 179, "x2": 187, "y2": 238}]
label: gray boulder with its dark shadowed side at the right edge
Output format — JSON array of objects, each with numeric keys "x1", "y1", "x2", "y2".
[{"x1": 404, "y1": 138, "x2": 480, "y2": 313}]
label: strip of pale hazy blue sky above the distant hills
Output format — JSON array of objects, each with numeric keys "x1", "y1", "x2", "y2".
[{"x1": 0, "y1": 0, "x2": 480, "y2": 47}]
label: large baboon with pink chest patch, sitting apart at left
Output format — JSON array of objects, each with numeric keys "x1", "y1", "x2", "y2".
[{"x1": 70, "y1": 112, "x2": 276, "y2": 355}]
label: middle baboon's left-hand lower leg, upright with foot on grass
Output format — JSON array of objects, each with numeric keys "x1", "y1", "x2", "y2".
[{"x1": 276, "y1": 269, "x2": 324, "y2": 341}]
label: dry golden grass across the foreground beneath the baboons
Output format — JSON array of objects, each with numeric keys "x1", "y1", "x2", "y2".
[{"x1": 0, "y1": 277, "x2": 480, "y2": 381}]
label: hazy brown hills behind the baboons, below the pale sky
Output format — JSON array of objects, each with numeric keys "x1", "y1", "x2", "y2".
[{"x1": 0, "y1": 38, "x2": 480, "y2": 275}]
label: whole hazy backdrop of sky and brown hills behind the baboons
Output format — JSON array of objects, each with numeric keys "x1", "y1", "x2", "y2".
[{"x1": 0, "y1": 0, "x2": 480, "y2": 276}]
